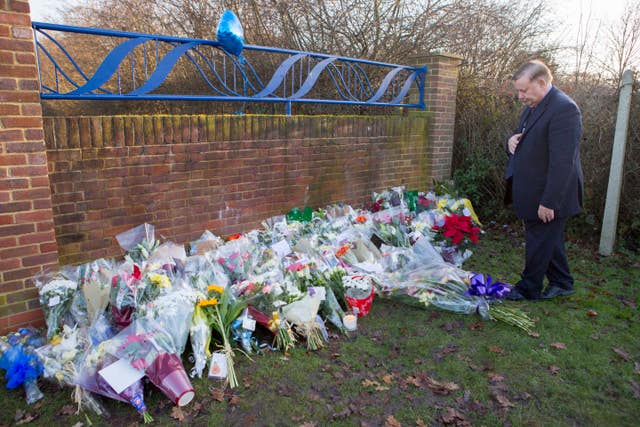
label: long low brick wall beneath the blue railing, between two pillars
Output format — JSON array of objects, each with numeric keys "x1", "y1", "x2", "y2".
[{"x1": 44, "y1": 115, "x2": 431, "y2": 264}]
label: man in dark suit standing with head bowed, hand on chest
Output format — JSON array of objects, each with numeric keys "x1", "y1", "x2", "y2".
[{"x1": 506, "y1": 61, "x2": 583, "y2": 300}]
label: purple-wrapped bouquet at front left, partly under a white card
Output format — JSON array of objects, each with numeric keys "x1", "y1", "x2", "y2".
[{"x1": 74, "y1": 343, "x2": 153, "y2": 423}]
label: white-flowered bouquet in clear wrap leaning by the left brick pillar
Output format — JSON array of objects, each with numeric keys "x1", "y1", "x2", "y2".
[{"x1": 34, "y1": 274, "x2": 78, "y2": 339}]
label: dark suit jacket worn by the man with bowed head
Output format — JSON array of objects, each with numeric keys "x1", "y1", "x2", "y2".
[{"x1": 506, "y1": 86, "x2": 584, "y2": 220}]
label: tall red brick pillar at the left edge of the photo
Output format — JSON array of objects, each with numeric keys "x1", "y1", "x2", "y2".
[{"x1": 0, "y1": 0, "x2": 58, "y2": 335}]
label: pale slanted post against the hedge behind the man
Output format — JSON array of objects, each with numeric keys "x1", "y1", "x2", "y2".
[{"x1": 600, "y1": 70, "x2": 633, "y2": 256}]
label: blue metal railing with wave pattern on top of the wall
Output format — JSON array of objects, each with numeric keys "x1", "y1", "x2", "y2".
[{"x1": 33, "y1": 22, "x2": 427, "y2": 114}]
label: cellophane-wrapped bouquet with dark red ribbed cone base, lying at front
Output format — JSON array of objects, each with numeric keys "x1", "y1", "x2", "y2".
[{"x1": 107, "y1": 318, "x2": 195, "y2": 406}]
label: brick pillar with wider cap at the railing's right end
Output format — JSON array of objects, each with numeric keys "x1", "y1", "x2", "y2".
[{"x1": 414, "y1": 54, "x2": 462, "y2": 181}]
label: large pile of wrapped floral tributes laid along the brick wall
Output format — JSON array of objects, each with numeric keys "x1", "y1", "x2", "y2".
[{"x1": 0, "y1": 187, "x2": 533, "y2": 421}]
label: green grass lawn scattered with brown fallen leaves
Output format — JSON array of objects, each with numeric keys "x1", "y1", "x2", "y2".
[{"x1": 0, "y1": 228, "x2": 640, "y2": 426}]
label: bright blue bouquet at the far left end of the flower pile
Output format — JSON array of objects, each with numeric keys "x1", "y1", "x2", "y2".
[{"x1": 0, "y1": 328, "x2": 44, "y2": 405}]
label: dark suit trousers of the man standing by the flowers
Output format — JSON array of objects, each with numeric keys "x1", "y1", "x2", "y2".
[{"x1": 516, "y1": 218, "x2": 573, "y2": 299}]
